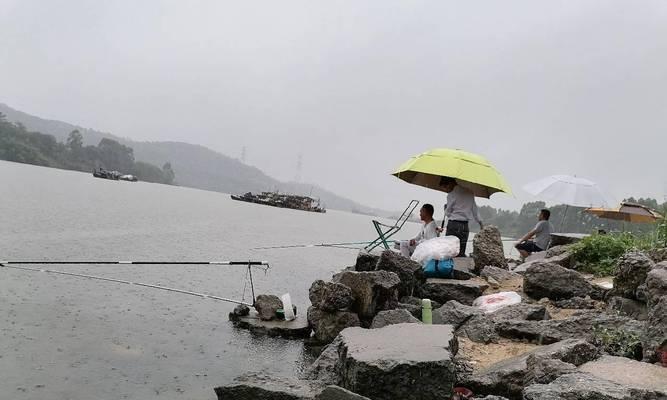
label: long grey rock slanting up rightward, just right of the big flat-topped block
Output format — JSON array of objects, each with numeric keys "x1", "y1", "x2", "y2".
[{"x1": 463, "y1": 340, "x2": 599, "y2": 399}]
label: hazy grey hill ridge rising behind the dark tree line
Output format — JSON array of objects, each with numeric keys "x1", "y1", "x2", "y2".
[{"x1": 0, "y1": 103, "x2": 390, "y2": 216}]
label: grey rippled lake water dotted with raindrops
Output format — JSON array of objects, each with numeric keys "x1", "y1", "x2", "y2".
[{"x1": 0, "y1": 161, "x2": 516, "y2": 399}]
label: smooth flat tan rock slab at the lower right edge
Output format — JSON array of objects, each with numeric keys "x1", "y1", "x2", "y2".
[{"x1": 579, "y1": 356, "x2": 667, "y2": 395}]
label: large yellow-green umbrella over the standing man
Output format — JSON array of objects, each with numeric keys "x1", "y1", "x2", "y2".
[{"x1": 392, "y1": 149, "x2": 512, "y2": 198}]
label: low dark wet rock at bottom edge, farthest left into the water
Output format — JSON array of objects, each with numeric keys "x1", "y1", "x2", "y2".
[{"x1": 214, "y1": 372, "x2": 323, "y2": 400}]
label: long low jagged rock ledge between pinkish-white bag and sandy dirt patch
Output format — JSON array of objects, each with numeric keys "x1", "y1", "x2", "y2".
[{"x1": 495, "y1": 311, "x2": 644, "y2": 344}]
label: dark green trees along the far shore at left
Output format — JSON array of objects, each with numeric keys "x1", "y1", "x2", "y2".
[{"x1": 0, "y1": 113, "x2": 176, "y2": 185}]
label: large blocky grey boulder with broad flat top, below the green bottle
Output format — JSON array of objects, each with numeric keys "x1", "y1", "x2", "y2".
[{"x1": 339, "y1": 324, "x2": 458, "y2": 400}]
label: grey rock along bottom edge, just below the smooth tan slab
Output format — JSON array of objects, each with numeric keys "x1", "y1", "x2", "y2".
[{"x1": 523, "y1": 372, "x2": 664, "y2": 400}]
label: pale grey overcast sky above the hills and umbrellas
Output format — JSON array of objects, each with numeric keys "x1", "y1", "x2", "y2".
[{"x1": 0, "y1": 0, "x2": 667, "y2": 209}]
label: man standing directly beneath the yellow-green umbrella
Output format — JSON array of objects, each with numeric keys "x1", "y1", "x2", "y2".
[{"x1": 440, "y1": 176, "x2": 484, "y2": 257}]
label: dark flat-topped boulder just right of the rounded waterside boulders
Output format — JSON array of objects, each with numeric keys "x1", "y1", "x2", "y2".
[{"x1": 334, "y1": 271, "x2": 401, "y2": 323}]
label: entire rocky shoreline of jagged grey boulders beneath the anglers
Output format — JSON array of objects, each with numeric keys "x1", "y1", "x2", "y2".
[{"x1": 222, "y1": 227, "x2": 667, "y2": 400}]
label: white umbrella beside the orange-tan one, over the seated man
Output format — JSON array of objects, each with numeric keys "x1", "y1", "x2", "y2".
[{"x1": 523, "y1": 175, "x2": 609, "y2": 231}]
